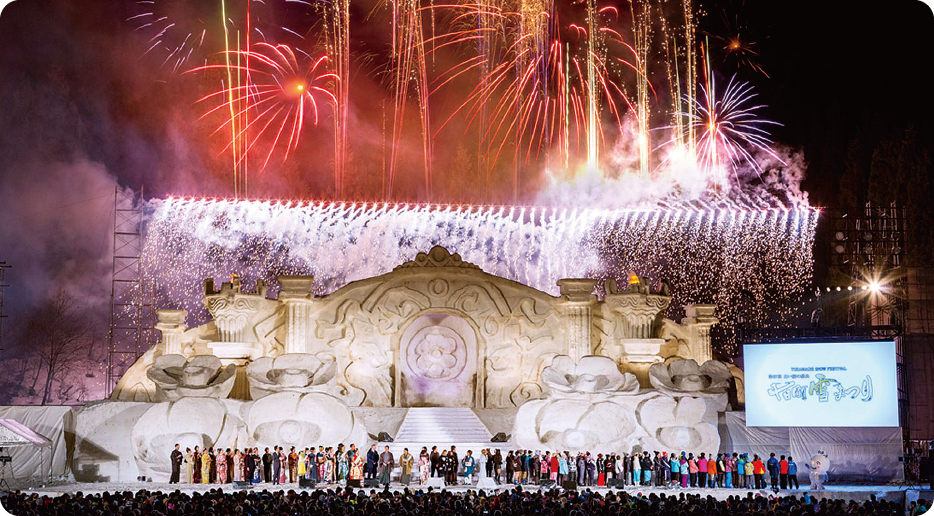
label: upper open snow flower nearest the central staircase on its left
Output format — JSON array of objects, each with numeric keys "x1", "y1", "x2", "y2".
[{"x1": 246, "y1": 353, "x2": 337, "y2": 400}]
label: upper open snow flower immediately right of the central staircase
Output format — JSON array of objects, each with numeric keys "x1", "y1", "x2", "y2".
[{"x1": 542, "y1": 355, "x2": 639, "y2": 398}]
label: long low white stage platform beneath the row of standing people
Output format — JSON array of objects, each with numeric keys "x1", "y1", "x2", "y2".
[{"x1": 14, "y1": 482, "x2": 934, "y2": 503}]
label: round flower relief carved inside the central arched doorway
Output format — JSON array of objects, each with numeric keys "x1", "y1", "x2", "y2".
[{"x1": 408, "y1": 326, "x2": 467, "y2": 380}]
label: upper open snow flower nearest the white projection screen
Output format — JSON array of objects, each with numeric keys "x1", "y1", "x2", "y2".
[{"x1": 649, "y1": 359, "x2": 733, "y2": 398}]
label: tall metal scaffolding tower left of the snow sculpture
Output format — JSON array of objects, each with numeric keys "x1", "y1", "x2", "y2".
[{"x1": 106, "y1": 187, "x2": 155, "y2": 397}]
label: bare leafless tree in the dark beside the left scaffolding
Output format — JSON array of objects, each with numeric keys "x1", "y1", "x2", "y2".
[{"x1": 25, "y1": 290, "x2": 92, "y2": 405}]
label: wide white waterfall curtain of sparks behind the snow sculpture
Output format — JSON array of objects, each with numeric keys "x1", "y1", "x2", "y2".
[{"x1": 143, "y1": 198, "x2": 818, "y2": 356}]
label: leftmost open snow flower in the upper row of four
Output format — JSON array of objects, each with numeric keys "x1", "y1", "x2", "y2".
[{"x1": 146, "y1": 355, "x2": 237, "y2": 401}]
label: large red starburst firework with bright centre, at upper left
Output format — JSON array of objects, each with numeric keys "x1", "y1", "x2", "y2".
[{"x1": 192, "y1": 43, "x2": 341, "y2": 169}]
